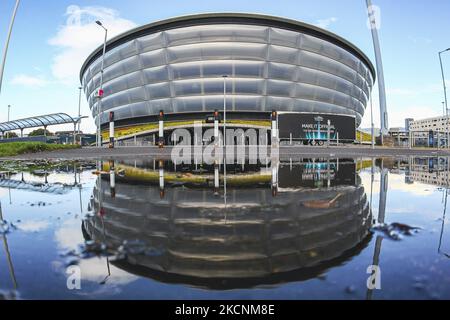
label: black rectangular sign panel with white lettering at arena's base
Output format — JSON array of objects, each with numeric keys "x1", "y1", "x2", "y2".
[{"x1": 278, "y1": 113, "x2": 356, "y2": 141}]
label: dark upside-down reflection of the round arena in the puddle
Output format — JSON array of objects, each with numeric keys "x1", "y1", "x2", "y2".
[{"x1": 83, "y1": 159, "x2": 371, "y2": 289}]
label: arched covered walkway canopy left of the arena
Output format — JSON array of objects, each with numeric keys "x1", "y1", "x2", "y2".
[{"x1": 0, "y1": 113, "x2": 86, "y2": 134}]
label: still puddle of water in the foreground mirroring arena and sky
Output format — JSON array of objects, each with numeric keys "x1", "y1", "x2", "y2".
[{"x1": 0, "y1": 158, "x2": 450, "y2": 299}]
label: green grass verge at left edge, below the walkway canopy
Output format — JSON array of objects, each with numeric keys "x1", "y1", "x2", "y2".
[{"x1": 0, "y1": 142, "x2": 80, "y2": 157}]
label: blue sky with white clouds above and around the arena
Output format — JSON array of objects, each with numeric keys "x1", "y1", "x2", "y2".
[{"x1": 0, "y1": 0, "x2": 450, "y2": 131}]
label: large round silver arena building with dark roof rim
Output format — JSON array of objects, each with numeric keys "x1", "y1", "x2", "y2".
[{"x1": 80, "y1": 13, "x2": 375, "y2": 143}]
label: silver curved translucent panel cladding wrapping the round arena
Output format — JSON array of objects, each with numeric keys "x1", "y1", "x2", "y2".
[{"x1": 81, "y1": 16, "x2": 374, "y2": 125}]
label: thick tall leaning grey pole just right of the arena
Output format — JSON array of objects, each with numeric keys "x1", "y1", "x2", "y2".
[{"x1": 366, "y1": 0, "x2": 388, "y2": 144}]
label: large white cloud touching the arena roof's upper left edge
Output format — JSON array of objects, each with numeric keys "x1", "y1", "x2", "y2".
[{"x1": 49, "y1": 5, "x2": 136, "y2": 84}]
